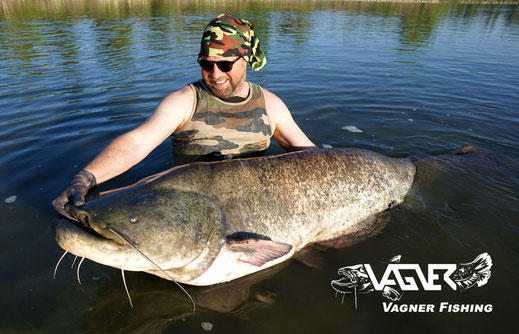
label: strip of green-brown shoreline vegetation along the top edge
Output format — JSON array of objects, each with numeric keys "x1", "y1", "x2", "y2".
[{"x1": 0, "y1": 0, "x2": 519, "y2": 23}]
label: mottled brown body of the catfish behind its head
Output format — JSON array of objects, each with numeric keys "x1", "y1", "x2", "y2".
[{"x1": 165, "y1": 150, "x2": 415, "y2": 248}]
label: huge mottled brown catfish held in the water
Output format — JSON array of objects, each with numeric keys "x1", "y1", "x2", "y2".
[{"x1": 55, "y1": 149, "x2": 416, "y2": 285}]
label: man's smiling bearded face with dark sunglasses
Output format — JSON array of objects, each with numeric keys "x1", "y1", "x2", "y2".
[{"x1": 200, "y1": 56, "x2": 247, "y2": 99}]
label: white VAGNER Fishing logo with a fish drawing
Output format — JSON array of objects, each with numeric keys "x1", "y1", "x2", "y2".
[{"x1": 331, "y1": 253, "x2": 492, "y2": 312}]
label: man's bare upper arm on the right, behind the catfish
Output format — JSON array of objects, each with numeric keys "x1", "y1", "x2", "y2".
[{"x1": 263, "y1": 89, "x2": 315, "y2": 152}]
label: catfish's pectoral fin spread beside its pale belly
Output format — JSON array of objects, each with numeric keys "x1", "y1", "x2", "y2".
[{"x1": 226, "y1": 239, "x2": 292, "y2": 267}]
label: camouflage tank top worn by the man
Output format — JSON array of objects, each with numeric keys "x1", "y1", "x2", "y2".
[{"x1": 172, "y1": 80, "x2": 272, "y2": 158}]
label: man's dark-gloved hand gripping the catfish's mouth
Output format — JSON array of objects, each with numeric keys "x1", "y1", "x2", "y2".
[{"x1": 52, "y1": 170, "x2": 97, "y2": 221}]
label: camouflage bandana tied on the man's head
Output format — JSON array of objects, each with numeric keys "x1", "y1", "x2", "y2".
[{"x1": 198, "y1": 14, "x2": 267, "y2": 71}]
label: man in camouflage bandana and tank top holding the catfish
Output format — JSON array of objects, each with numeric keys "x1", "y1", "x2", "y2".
[{"x1": 52, "y1": 14, "x2": 314, "y2": 219}]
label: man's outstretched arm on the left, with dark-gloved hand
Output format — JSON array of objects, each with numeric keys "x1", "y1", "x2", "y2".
[{"x1": 52, "y1": 86, "x2": 195, "y2": 219}]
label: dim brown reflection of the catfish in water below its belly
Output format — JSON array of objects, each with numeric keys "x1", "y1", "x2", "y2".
[{"x1": 85, "y1": 261, "x2": 290, "y2": 333}]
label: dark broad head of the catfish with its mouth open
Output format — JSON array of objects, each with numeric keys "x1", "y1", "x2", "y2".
[{"x1": 55, "y1": 187, "x2": 226, "y2": 282}]
